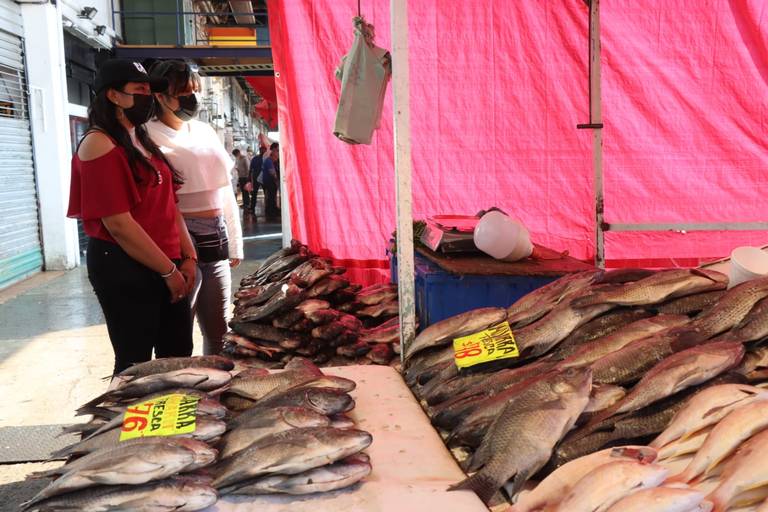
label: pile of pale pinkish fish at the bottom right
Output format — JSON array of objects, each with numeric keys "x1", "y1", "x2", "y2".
[{"x1": 511, "y1": 384, "x2": 768, "y2": 512}]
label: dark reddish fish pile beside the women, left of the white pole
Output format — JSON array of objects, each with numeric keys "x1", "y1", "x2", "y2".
[{"x1": 224, "y1": 241, "x2": 400, "y2": 368}]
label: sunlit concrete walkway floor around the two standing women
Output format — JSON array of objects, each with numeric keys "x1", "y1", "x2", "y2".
[{"x1": 0, "y1": 211, "x2": 281, "y2": 511}]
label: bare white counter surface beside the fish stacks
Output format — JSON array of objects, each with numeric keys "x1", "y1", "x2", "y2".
[{"x1": 207, "y1": 365, "x2": 488, "y2": 512}]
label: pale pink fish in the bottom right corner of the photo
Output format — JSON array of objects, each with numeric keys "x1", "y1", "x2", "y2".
[{"x1": 707, "y1": 430, "x2": 768, "y2": 512}]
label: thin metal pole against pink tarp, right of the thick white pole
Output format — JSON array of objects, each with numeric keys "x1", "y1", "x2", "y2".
[{"x1": 589, "y1": 0, "x2": 605, "y2": 268}]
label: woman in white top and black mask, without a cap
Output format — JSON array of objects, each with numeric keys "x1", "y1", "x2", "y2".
[{"x1": 146, "y1": 61, "x2": 243, "y2": 354}]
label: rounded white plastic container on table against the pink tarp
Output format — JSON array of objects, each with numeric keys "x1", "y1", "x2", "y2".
[{"x1": 474, "y1": 210, "x2": 533, "y2": 261}]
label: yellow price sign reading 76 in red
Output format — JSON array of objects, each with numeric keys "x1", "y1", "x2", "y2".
[{"x1": 120, "y1": 393, "x2": 200, "y2": 441}]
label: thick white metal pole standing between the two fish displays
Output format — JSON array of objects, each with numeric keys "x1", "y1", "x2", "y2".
[{"x1": 389, "y1": 0, "x2": 416, "y2": 361}]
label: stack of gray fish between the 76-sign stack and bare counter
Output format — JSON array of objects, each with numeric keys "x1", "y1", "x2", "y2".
[{"x1": 213, "y1": 358, "x2": 372, "y2": 495}]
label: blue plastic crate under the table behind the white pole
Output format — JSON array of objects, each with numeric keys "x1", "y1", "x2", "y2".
[{"x1": 389, "y1": 253, "x2": 557, "y2": 329}]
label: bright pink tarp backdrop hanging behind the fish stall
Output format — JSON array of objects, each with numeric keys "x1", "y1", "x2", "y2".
[{"x1": 268, "y1": 0, "x2": 768, "y2": 279}]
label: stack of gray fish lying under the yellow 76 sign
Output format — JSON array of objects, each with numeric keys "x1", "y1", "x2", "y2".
[{"x1": 22, "y1": 356, "x2": 234, "y2": 512}]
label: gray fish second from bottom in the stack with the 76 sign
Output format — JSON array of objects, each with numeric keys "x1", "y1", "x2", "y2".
[{"x1": 27, "y1": 437, "x2": 217, "y2": 482}]
